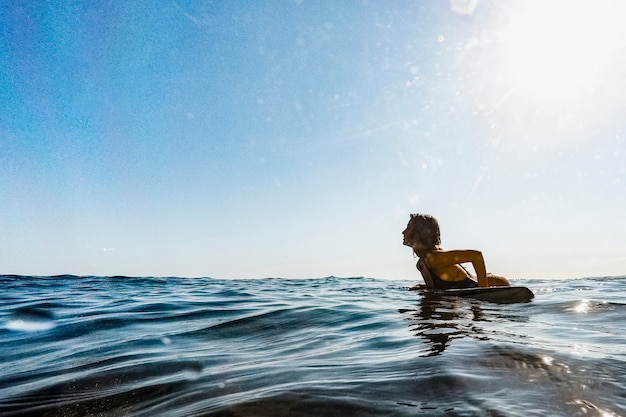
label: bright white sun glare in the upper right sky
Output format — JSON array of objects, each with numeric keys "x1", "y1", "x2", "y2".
[{"x1": 505, "y1": 0, "x2": 626, "y2": 100}]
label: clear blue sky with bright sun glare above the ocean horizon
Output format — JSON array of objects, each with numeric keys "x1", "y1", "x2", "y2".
[{"x1": 0, "y1": 0, "x2": 626, "y2": 280}]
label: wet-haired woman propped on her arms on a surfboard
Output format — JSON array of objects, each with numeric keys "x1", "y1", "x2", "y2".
[{"x1": 402, "y1": 214, "x2": 511, "y2": 290}]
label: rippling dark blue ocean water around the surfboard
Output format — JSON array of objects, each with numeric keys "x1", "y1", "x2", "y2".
[{"x1": 0, "y1": 276, "x2": 626, "y2": 417}]
